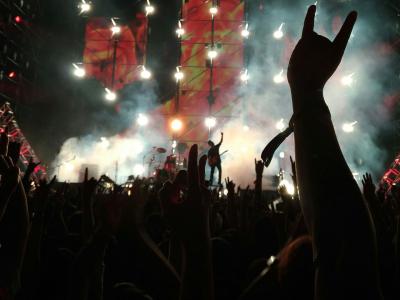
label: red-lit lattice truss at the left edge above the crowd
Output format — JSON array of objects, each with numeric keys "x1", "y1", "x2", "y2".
[{"x1": 0, "y1": 102, "x2": 46, "y2": 179}]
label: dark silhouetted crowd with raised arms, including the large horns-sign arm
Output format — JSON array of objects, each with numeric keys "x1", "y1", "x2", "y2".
[{"x1": 0, "y1": 5, "x2": 400, "y2": 300}]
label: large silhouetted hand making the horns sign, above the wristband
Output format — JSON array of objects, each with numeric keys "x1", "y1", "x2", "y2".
[{"x1": 287, "y1": 5, "x2": 357, "y2": 109}]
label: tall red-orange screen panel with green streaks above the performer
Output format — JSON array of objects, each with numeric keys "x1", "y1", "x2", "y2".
[{"x1": 160, "y1": 0, "x2": 247, "y2": 144}]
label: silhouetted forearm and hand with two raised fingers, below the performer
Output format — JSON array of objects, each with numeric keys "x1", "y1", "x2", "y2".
[{"x1": 160, "y1": 145, "x2": 214, "y2": 300}]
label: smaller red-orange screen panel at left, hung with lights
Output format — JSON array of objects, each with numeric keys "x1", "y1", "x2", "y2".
[{"x1": 82, "y1": 13, "x2": 151, "y2": 92}]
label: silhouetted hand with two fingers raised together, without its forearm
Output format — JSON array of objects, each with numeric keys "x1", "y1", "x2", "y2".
[{"x1": 160, "y1": 145, "x2": 211, "y2": 246}]
